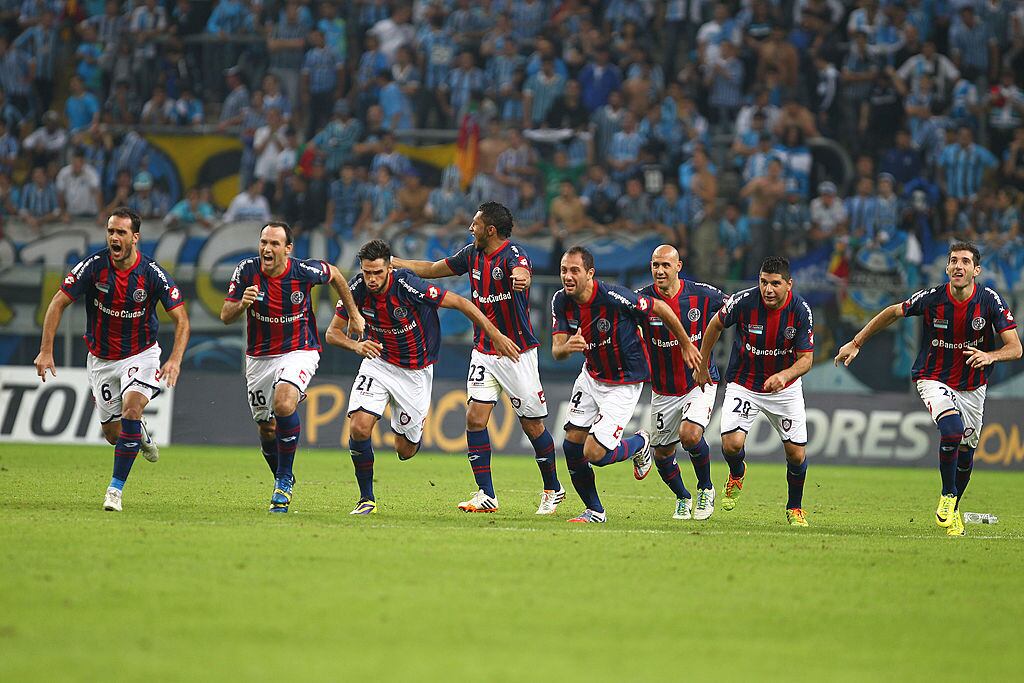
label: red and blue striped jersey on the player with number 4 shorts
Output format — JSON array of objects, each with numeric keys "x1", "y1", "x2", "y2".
[{"x1": 551, "y1": 280, "x2": 654, "y2": 384}]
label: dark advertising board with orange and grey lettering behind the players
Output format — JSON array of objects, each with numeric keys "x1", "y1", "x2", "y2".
[{"x1": 163, "y1": 375, "x2": 1024, "y2": 469}]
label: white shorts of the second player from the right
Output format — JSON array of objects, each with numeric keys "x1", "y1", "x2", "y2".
[{"x1": 722, "y1": 380, "x2": 807, "y2": 445}]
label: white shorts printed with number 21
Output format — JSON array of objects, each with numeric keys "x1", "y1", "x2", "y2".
[{"x1": 348, "y1": 358, "x2": 434, "y2": 443}]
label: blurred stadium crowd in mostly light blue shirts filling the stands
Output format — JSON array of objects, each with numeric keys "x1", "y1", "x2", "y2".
[{"x1": 0, "y1": 0, "x2": 1024, "y2": 278}]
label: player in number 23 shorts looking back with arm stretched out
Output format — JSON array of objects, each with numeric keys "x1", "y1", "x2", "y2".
[{"x1": 393, "y1": 202, "x2": 565, "y2": 515}]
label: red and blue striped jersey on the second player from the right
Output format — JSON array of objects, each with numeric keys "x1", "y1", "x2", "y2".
[{"x1": 718, "y1": 287, "x2": 814, "y2": 393}]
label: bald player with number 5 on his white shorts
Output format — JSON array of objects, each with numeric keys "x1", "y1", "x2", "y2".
[{"x1": 637, "y1": 245, "x2": 726, "y2": 520}]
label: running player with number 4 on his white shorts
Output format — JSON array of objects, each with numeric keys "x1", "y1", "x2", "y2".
[{"x1": 551, "y1": 247, "x2": 699, "y2": 523}]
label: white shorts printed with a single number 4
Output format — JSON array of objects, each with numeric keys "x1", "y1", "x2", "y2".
[{"x1": 566, "y1": 366, "x2": 643, "y2": 451}]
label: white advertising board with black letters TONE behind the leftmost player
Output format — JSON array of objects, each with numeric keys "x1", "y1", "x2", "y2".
[{"x1": 0, "y1": 367, "x2": 175, "y2": 445}]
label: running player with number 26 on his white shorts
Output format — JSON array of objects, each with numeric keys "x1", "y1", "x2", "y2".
[{"x1": 220, "y1": 222, "x2": 365, "y2": 513}]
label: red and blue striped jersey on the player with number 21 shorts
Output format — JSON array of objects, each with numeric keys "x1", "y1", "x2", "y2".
[{"x1": 335, "y1": 268, "x2": 447, "y2": 370}]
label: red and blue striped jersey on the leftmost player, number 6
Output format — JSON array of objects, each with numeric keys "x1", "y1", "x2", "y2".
[{"x1": 60, "y1": 249, "x2": 184, "y2": 360}]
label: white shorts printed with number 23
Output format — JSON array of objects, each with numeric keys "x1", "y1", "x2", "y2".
[{"x1": 466, "y1": 348, "x2": 548, "y2": 419}]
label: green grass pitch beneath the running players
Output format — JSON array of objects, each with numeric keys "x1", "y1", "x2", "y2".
[{"x1": 0, "y1": 444, "x2": 1024, "y2": 682}]
